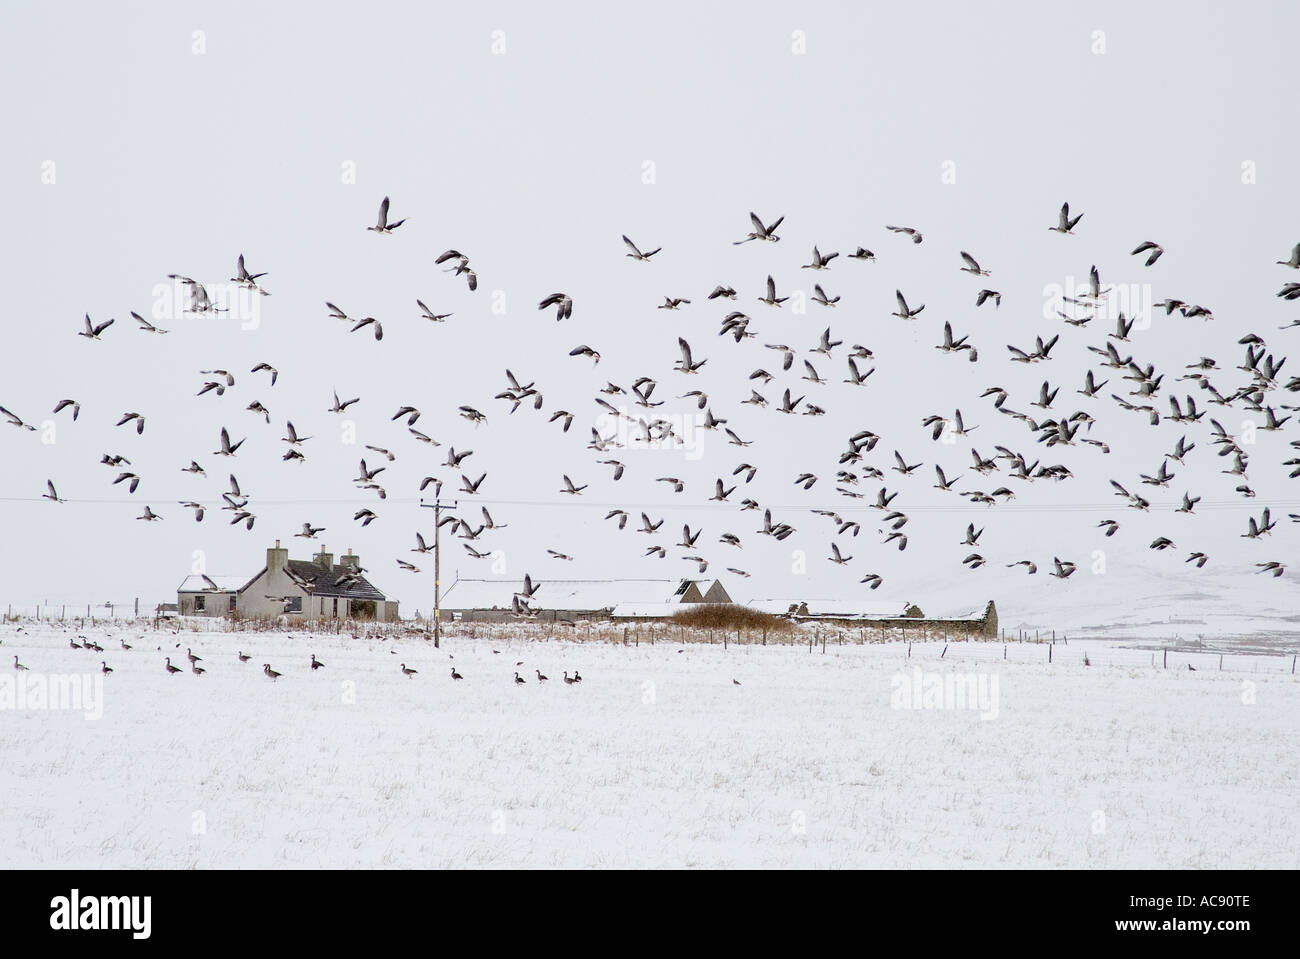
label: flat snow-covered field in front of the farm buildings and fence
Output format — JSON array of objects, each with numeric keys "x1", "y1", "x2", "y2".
[{"x1": 0, "y1": 621, "x2": 1300, "y2": 868}]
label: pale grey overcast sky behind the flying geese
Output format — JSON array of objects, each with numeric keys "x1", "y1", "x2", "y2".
[{"x1": 0, "y1": 3, "x2": 1300, "y2": 617}]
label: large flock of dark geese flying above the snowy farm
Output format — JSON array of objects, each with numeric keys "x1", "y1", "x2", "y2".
[{"x1": 0, "y1": 198, "x2": 1300, "y2": 617}]
